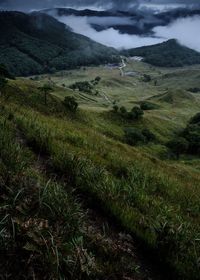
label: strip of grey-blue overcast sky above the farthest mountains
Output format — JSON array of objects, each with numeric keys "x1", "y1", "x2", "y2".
[{"x1": 0, "y1": 0, "x2": 200, "y2": 10}]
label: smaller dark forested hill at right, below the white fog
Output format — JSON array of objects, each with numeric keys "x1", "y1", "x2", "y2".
[{"x1": 122, "y1": 40, "x2": 200, "y2": 67}]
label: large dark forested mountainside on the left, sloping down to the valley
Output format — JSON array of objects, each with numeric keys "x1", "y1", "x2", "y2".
[{"x1": 0, "y1": 12, "x2": 118, "y2": 76}]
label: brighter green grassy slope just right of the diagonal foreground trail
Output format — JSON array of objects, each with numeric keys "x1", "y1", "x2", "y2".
[{"x1": 2, "y1": 88, "x2": 200, "y2": 279}]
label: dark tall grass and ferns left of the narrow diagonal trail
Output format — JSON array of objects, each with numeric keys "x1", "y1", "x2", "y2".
[{"x1": 0, "y1": 105, "x2": 157, "y2": 280}]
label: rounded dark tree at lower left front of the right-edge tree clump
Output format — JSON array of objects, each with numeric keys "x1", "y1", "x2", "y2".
[{"x1": 167, "y1": 137, "x2": 189, "y2": 159}]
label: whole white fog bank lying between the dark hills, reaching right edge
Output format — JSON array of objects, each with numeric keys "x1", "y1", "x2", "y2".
[{"x1": 58, "y1": 15, "x2": 200, "y2": 52}]
